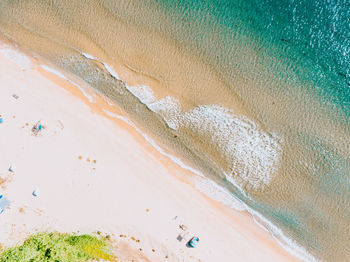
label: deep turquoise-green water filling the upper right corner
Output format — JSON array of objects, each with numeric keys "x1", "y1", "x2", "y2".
[{"x1": 161, "y1": 0, "x2": 350, "y2": 114}]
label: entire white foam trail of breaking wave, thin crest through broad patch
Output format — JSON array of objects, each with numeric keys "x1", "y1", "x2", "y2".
[{"x1": 83, "y1": 53, "x2": 282, "y2": 190}]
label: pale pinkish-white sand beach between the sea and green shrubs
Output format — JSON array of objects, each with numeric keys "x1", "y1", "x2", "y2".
[{"x1": 0, "y1": 46, "x2": 297, "y2": 261}]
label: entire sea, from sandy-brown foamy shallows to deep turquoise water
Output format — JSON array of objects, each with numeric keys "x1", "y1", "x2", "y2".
[{"x1": 0, "y1": 0, "x2": 350, "y2": 261}]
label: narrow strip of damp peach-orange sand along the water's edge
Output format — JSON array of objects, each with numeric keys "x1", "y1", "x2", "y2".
[{"x1": 2, "y1": 42, "x2": 300, "y2": 261}]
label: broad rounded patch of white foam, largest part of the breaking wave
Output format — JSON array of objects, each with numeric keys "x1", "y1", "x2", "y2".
[{"x1": 180, "y1": 105, "x2": 281, "y2": 189}]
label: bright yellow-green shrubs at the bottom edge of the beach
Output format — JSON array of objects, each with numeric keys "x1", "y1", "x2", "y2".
[{"x1": 0, "y1": 233, "x2": 116, "y2": 262}]
